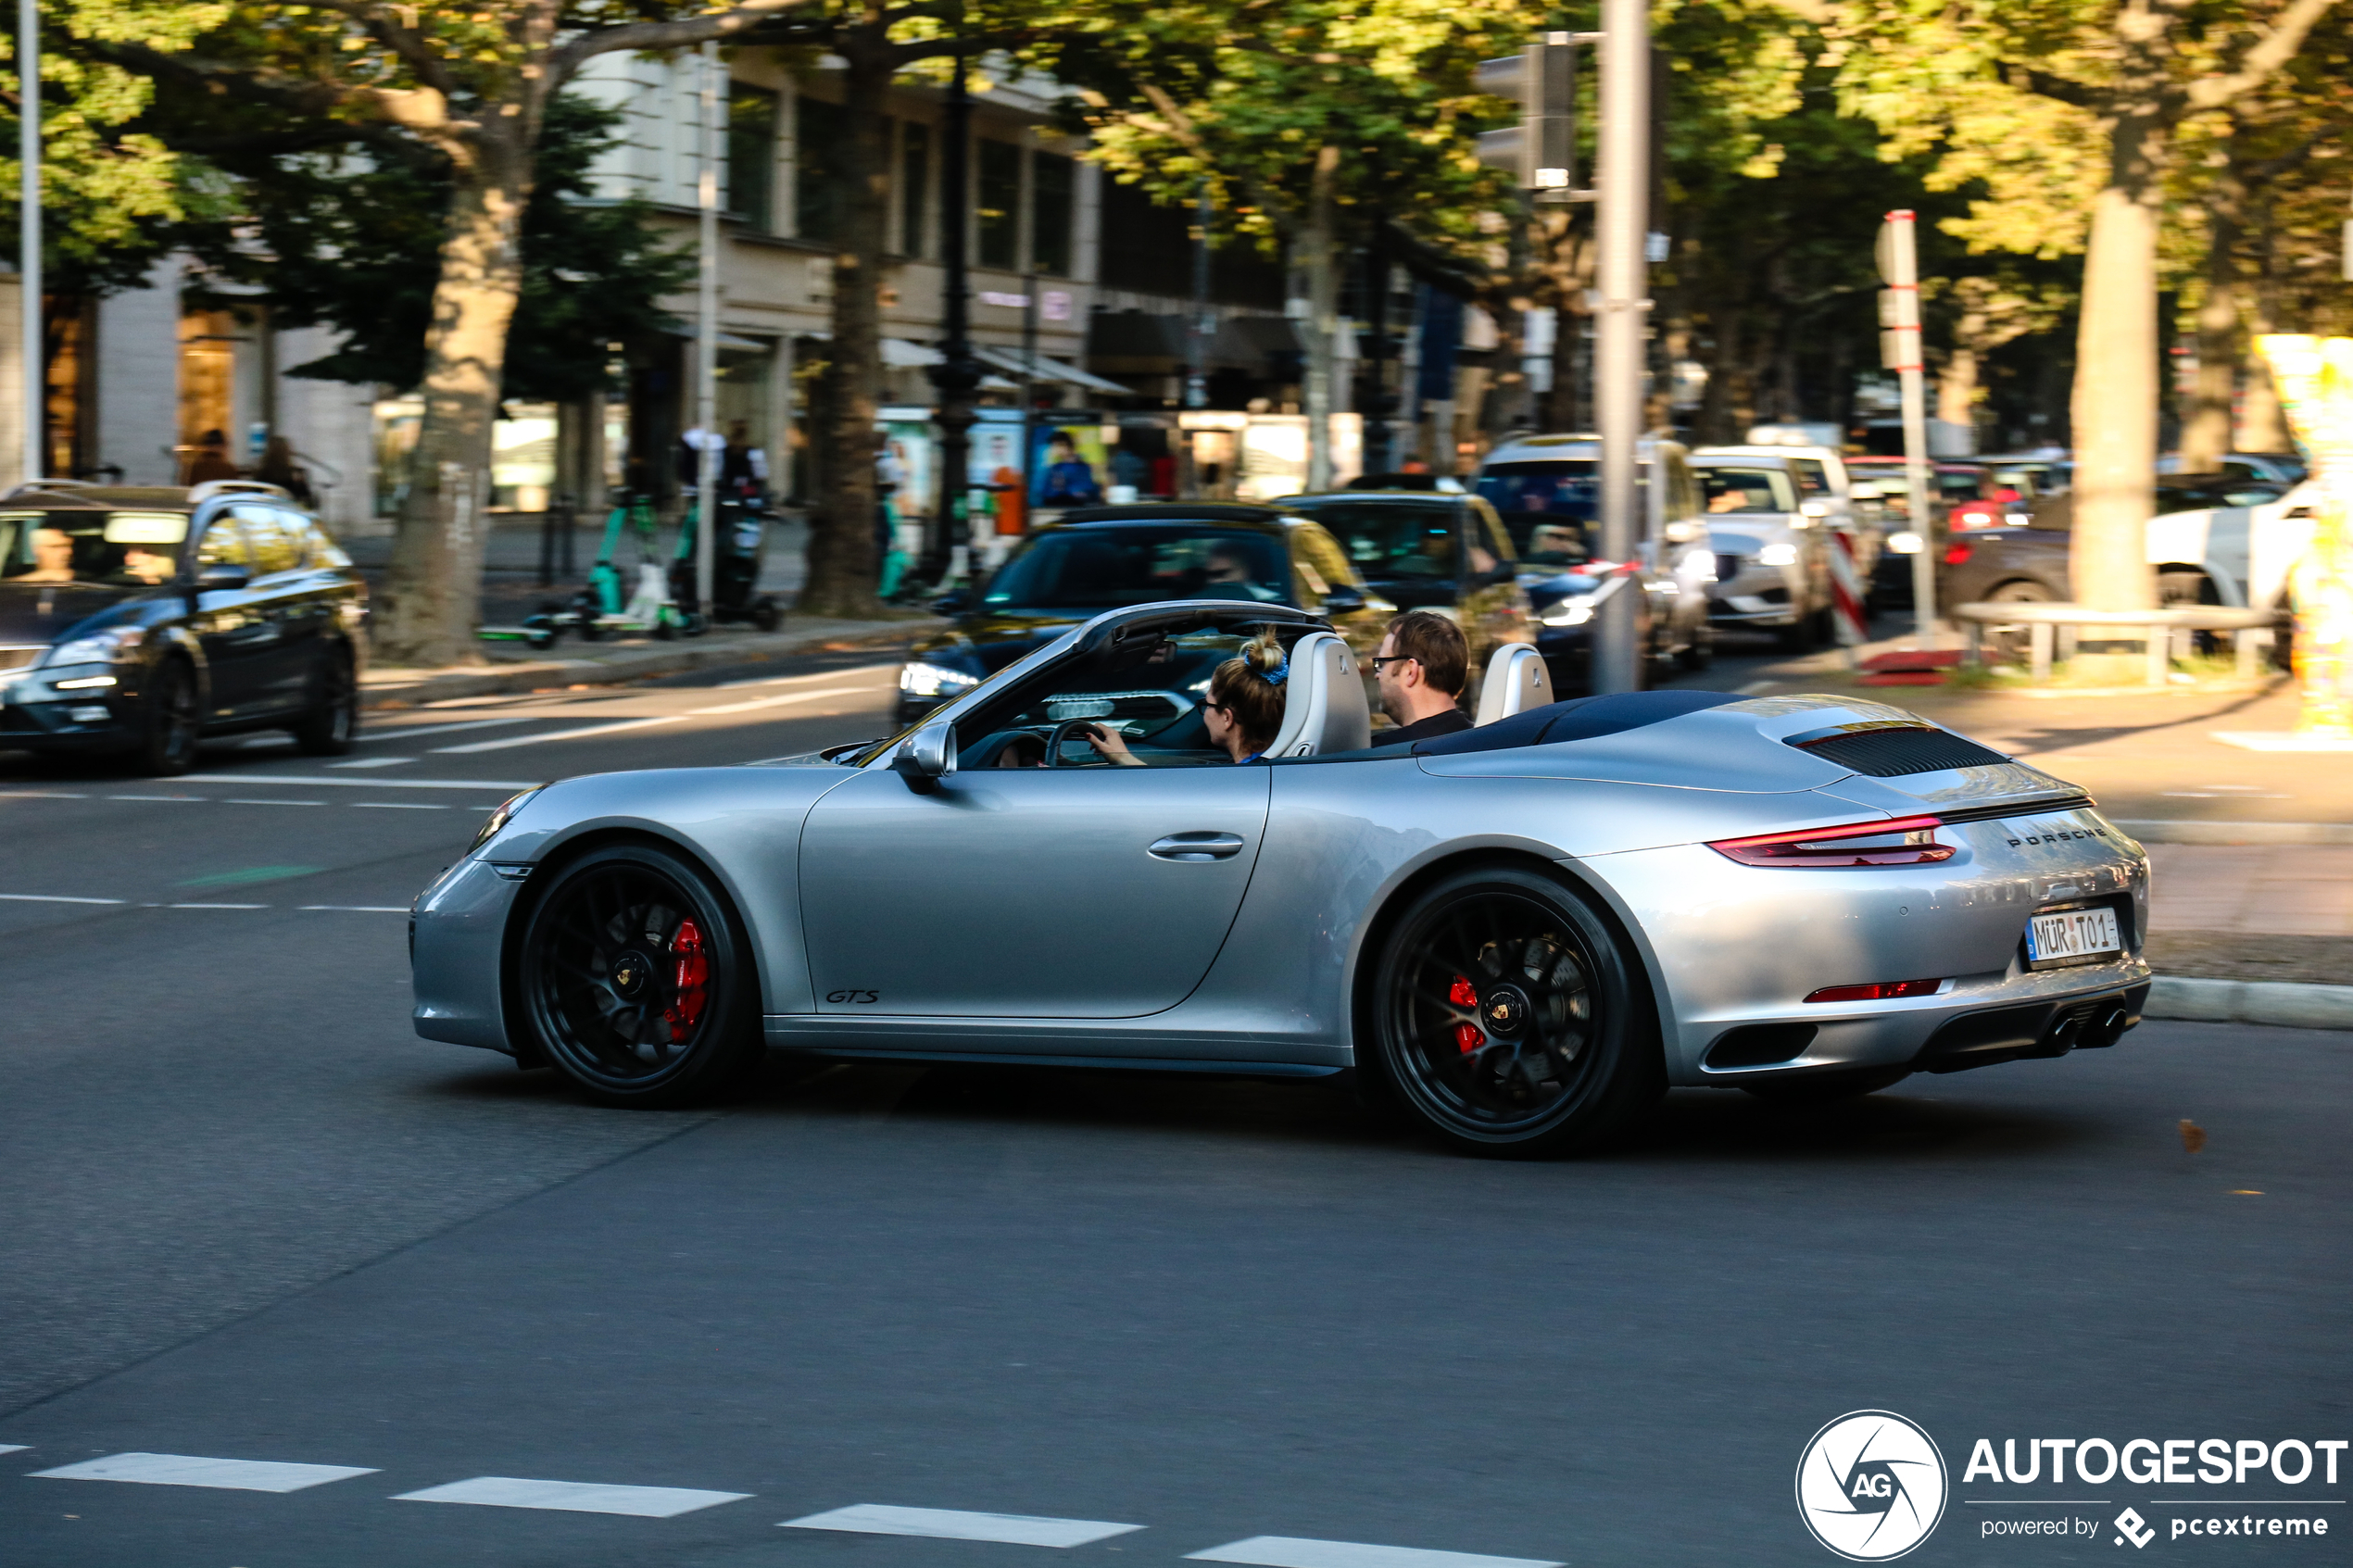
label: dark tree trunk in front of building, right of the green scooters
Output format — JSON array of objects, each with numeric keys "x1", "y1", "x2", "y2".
[{"x1": 798, "y1": 22, "x2": 892, "y2": 621}]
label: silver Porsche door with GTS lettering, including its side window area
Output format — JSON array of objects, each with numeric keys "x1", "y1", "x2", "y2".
[{"x1": 800, "y1": 630, "x2": 1271, "y2": 1018}]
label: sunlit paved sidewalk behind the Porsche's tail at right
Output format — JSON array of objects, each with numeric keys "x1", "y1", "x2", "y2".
[{"x1": 1713, "y1": 637, "x2": 2353, "y2": 1030}]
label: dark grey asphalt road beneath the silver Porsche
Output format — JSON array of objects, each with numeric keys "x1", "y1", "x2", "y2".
[{"x1": 0, "y1": 630, "x2": 2353, "y2": 1568}]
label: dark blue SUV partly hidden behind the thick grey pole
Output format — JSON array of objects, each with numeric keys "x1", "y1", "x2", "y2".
[{"x1": 1473, "y1": 435, "x2": 1716, "y2": 691}]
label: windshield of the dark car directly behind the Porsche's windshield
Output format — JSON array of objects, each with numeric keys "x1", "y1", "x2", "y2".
[{"x1": 984, "y1": 521, "x2": 1291, "y2": 613}]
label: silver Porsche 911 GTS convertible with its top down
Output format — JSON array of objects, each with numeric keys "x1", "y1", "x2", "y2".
[{"x1": 409, "y1": 599, "x2": 2148, "y2": 1154}]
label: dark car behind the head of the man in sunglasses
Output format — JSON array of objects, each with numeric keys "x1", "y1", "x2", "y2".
[{"x1": 1271, "y1": 486, "x2": 1534, "y2": 691}]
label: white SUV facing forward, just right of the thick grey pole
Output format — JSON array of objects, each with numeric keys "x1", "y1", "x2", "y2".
[{"x1": 1692, "y1": 454, "x2": 1831, "y2": 651}]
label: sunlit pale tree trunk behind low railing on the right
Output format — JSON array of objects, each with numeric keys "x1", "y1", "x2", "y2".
[{"x1": 2073, "y1": 104, "x2": 2165, "y2": 608}]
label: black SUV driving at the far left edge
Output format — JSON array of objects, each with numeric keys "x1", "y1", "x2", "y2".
[{"x1": 0, "y1": 480, "x2": 367, "y2": 773}]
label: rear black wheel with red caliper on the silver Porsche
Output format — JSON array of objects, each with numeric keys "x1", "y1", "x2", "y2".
[{"x1": 1365, "y1": 865, "x2": 1666, "y2": 1159}]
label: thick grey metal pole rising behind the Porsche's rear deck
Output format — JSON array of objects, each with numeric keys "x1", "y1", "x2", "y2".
[{"x1": 1593, "y1": 0, "x2": 1650, "y2": 694}]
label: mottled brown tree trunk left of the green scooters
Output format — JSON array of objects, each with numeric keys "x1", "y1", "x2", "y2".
[{"x1": 374, "y1": 125, "x2": 532, "y2": 665}]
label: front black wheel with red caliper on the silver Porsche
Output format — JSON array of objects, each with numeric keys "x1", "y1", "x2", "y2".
[{"x1": 518, "y1": 844, "x2": 760, "y2": 1108}]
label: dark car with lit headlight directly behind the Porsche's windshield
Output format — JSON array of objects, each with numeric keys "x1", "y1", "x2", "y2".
[{"x1": 899, "y1": 501, "x2": 1398, "y2": 724}]
